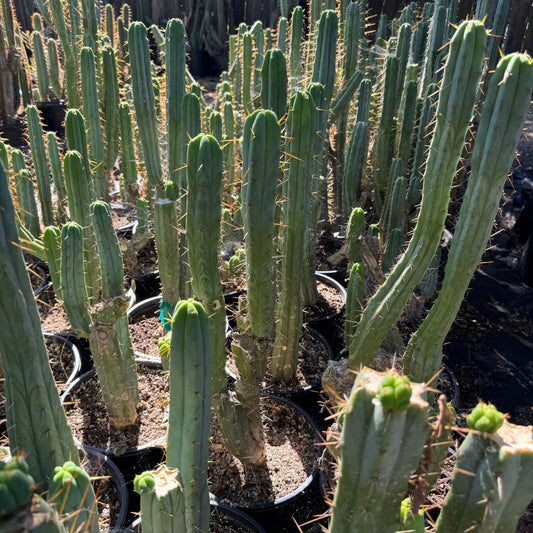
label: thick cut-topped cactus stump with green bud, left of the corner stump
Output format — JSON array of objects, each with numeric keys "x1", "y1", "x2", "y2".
[{"x1": 329, "y1": 368, "x2": 429, "y2": 533}]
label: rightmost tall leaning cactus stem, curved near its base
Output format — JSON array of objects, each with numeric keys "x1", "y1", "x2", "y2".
[{"x1": 404, "y1": 54, "x2": 533, "y2": 380}]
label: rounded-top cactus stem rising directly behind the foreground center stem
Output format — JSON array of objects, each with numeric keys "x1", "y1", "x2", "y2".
[{"x1": 186, "y1": 134, "x2": 226, "y2": 391}]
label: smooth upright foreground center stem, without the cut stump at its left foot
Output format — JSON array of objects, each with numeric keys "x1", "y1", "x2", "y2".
[{"x1": 167, "y1": 299, "x2": 212, "y2": 533}]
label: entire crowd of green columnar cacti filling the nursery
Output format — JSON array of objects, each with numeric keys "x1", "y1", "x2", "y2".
[{"x1": 0, "y1": 0, "x2": 533, "y2": 532}]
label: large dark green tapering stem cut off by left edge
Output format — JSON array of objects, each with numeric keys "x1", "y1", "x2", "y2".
[{"x1": 0, "y1": 165, "x2": 79, "y2": 490}]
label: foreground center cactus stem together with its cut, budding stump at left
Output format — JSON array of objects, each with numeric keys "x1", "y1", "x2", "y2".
[{"x1": 134, "y1": 299, "x2": 211, "y2": 533}]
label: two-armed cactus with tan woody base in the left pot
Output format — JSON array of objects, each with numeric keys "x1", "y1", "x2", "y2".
[{"x1": 61, "y1": 202, "x2": 139, "y2": 428}]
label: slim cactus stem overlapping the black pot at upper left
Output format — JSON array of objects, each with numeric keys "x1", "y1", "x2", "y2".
[{"x1": 26, "y1": 105, "x2": 54, "y2": 226}]
